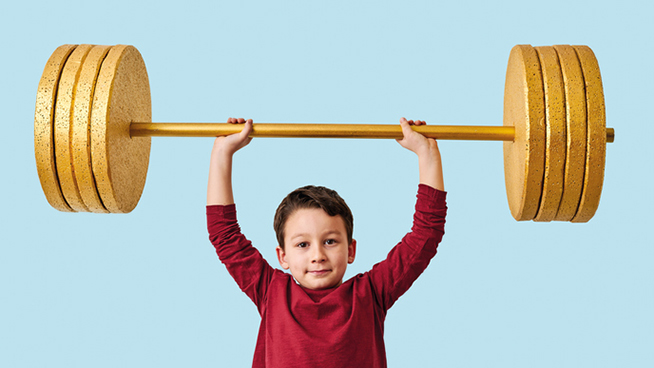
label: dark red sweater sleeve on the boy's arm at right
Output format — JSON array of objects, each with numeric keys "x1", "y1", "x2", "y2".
[{"x1": 370, "y1": 184, "x2": 447, "y2": 310}]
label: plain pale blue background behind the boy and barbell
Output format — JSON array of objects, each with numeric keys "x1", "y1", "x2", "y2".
[{"x1": 0, "y1": 0, "x2": 654, "y2": 367}]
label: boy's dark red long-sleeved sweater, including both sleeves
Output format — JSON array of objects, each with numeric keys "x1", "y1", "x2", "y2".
[{"x1": 207, "y1": 185, "x2": 447, "y2": 367}]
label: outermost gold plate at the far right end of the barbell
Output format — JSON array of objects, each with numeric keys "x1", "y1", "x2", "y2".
[{"x1": 572, "y1": 46, "x2": 606, "y2": 222}]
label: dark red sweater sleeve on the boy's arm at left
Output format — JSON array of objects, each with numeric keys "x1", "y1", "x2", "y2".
[{"x1": 207, "y1": 204, "x2": 274, "y2": 313}]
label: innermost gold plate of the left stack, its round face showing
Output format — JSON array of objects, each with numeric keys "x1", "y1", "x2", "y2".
[{"x1": 91, "y1": 45, "x2": 152, "y2": 213}]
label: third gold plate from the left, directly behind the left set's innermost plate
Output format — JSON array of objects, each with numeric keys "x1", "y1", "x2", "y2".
[{"x1": 71, "y1": 45, "x2": 111, "y2": 213}]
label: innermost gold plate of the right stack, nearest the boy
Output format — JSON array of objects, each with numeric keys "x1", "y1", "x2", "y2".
[{"x1": 504, "y1": 45, "x2": 545, "y2": 221}]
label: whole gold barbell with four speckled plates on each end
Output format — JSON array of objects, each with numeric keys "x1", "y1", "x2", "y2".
[{"x1": 34, "y1": 45, "x2": 614, "y2": 222}]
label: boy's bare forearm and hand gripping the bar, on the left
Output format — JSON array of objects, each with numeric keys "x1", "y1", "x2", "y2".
[{"x1": 207, "y1": 118, "x2": 252, "y2": 205}]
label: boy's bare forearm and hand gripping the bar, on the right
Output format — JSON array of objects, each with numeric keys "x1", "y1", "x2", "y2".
[{"x1": 397, "y1": 118, "x2": 445, "y2": 190}]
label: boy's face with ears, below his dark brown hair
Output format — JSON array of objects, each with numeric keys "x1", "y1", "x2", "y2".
[{"x1": 277, "y1": 208, "x2": 356, "y2": 290}]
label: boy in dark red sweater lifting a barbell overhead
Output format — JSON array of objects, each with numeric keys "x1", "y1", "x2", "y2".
[{"x1": 207, "y1": 118, "x2": 447, "y2": 367}]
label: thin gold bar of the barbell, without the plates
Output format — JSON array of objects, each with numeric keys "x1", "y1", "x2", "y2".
[{"x1": 130, "y1": 123, "x2": 615, "y2": 142}]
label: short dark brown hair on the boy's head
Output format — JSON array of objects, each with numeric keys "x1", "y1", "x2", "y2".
[{"x1": 273, "y1": 185, "x2": 354, "y2": 249}]
